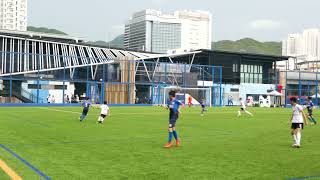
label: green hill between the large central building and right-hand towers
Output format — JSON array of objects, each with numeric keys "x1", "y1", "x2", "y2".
[{"x1": 212, "y1": 38, "x2": 281, "y2": 55}]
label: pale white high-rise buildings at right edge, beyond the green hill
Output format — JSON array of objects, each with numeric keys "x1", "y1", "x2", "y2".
[{"x1": 282, "y1": 28, "x2": 320, "y2": 71}]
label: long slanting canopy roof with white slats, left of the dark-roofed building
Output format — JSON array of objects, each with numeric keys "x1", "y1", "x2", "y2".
[{"x1": 0, "y1": 30, "x2": 201, "y2": 76}]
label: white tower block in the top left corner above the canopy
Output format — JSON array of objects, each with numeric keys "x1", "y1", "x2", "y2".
[{"x1": 0, "y1": 0, "x2": 28, "y2": 31}]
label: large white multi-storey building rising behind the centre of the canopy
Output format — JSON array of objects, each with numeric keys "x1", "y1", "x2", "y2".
[{"x1": 125, "y1": 9, "x2": 212, "y2": 53}]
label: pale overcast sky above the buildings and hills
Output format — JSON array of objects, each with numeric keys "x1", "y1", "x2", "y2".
[{"x1": 28, "y1": 0, "x2": 320, "y2": 41}]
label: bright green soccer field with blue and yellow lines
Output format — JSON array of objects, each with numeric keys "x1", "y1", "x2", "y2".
[{"x1": 0, "y1": 107, "x2": 320, "y2": 180}]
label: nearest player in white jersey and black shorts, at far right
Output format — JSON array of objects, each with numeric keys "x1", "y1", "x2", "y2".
[{"x1": 289, "y1": 97, "x2": 308, "y2": 148}]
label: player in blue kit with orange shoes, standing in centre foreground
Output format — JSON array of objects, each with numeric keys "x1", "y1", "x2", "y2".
[{"x1": 164, "y1": 91, "x2": 183, "y2": 148}]
